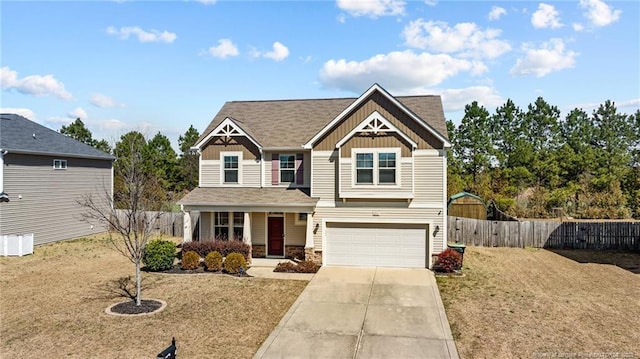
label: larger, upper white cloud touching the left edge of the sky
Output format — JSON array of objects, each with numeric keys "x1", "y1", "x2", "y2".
[{"x1": 0, "y1": 66, "x2": 73, "y2": 100}]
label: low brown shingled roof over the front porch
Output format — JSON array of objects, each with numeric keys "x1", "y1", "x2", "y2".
[{"x1": 178, "y1": 187, "x2": 318, "y2": 207}]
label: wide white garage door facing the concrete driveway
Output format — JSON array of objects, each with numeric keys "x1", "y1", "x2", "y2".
[{"x1": 325, "y1": 223, "x2": 428, "y2": 268}]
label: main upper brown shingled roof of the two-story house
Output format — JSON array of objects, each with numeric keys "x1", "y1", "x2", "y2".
[{"x1": 196, "y1": 87, "x2": 447, "y2": 148}]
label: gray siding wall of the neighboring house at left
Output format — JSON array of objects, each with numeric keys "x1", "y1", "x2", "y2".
[{"x1": 0, "y1": 153, "x2": 113, "y2": 245}]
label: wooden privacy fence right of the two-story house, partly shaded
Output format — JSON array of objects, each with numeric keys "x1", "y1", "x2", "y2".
[{"x1": 448, "y1": 217, "x2": 640, "y2": 251}]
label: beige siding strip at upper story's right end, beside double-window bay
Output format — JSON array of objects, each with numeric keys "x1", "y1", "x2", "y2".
[{"x1": 414, "y1": 154, "x2": 444, "y2": 204}]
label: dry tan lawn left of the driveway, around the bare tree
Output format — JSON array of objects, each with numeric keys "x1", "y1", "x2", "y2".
[{"x1": 0, "y1": 236, "x2": 307, "y2": 358}]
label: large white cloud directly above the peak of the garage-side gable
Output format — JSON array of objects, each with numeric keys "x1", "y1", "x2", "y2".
[{"x1": 319, "y1": 50, "x2": 481, "y2": 93}]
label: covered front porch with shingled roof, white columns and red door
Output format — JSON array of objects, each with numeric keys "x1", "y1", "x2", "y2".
[{"x1": 179, "y1": 187, "x2": 317, "y2": 259}]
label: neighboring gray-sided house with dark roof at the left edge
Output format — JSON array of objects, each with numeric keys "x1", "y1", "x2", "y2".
[{"x1": 0, "y1": 114, "x2": 114, "y2": 244}]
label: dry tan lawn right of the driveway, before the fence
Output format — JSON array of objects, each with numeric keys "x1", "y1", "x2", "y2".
[{"x1": 437, "y1": 247, "x2": 640, "y2": 359}]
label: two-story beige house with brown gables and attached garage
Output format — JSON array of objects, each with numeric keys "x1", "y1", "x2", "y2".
[{"x1": 179, "y1": 84, "x2": 450, "y2": 268}]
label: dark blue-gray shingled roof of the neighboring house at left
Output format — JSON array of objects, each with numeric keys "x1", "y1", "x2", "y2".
[{"x1": 0, "y1": 114, "x2": 114, "y2": 160}]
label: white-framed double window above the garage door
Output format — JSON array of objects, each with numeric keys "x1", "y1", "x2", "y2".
[{"x1": 354, "y1": 149, "x2": 399, "y2": 185}]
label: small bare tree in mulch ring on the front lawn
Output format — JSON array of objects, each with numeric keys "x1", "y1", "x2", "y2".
[{"x1": 78, "y1": 135, "x2": 162, "y2": 305}]
